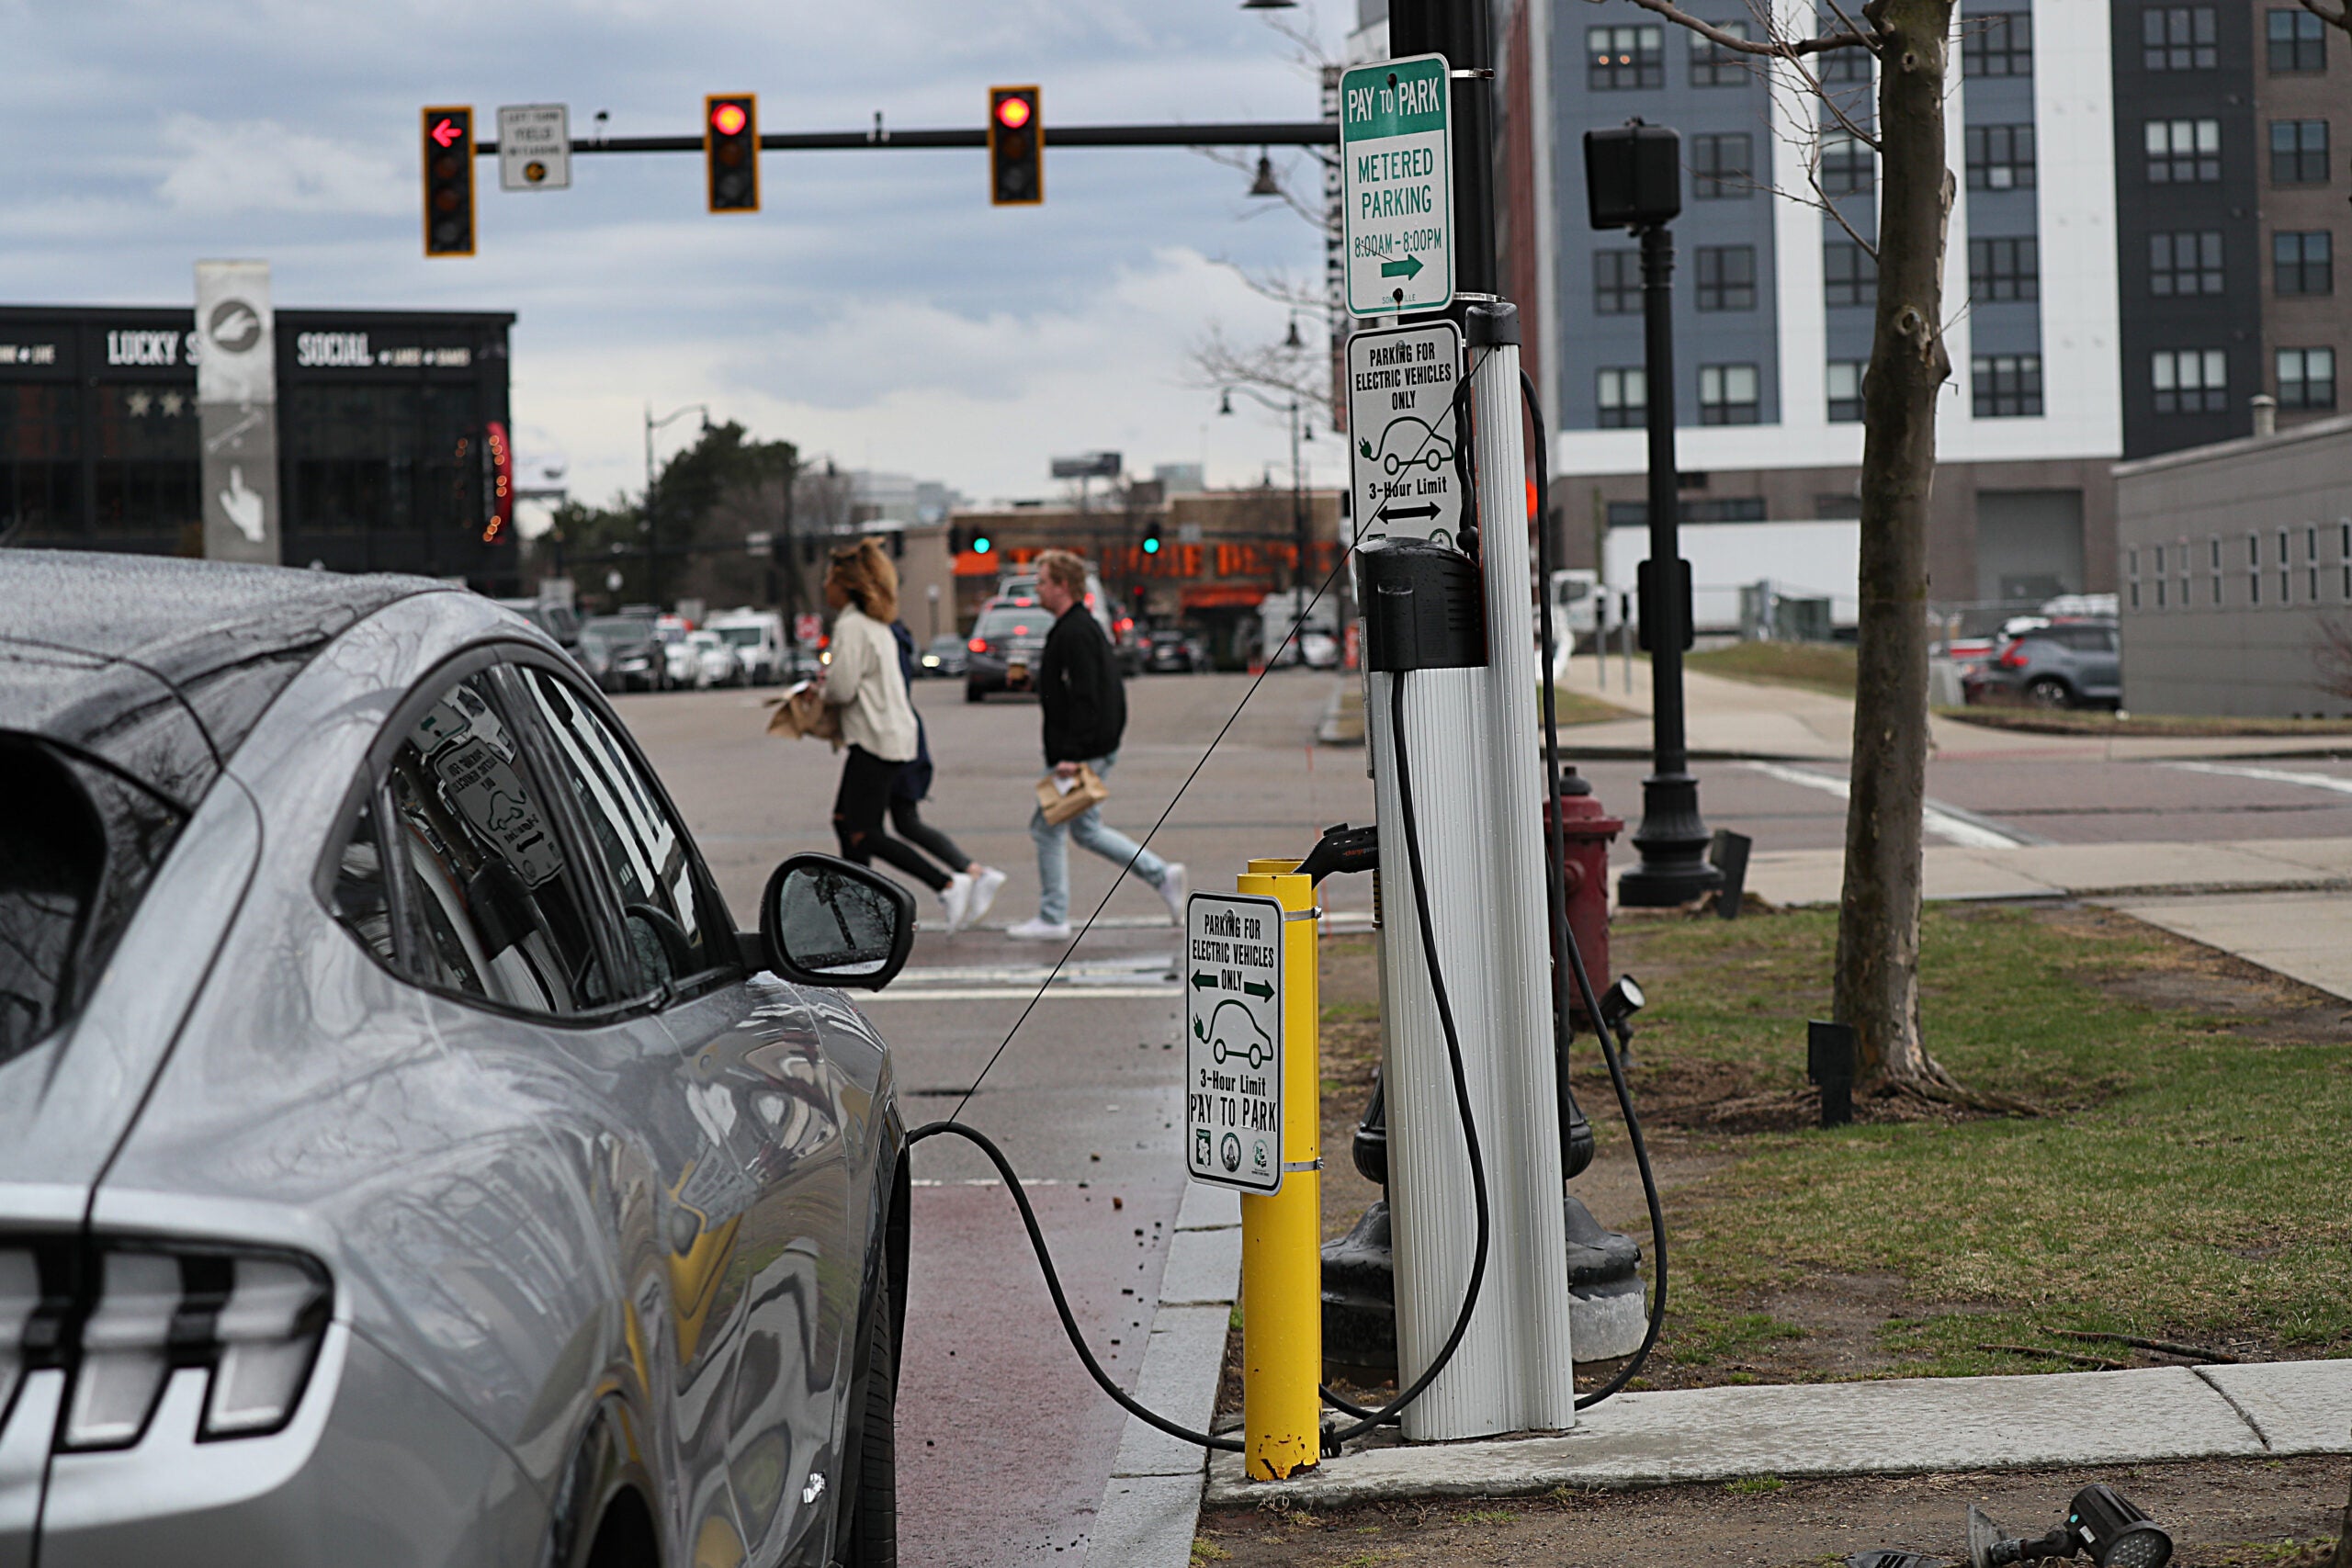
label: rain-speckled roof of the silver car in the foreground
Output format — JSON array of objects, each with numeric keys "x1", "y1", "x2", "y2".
[{"x1": 0, "y1": 550, "x2": 444, "y2": 808}]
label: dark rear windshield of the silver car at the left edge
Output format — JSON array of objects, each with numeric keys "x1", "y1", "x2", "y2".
[{"x1": 0, "y1": 736, "x2": 181, "y2": 1063}]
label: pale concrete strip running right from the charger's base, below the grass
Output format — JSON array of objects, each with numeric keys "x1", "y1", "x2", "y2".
[{"x1": 1206, "y1": 1359, "x2": 2352, "y2": 1506}]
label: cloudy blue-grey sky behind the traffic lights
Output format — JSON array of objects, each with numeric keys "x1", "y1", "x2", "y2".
[{"x1": 0, "y1": 0, "x2": 1352, "y2": 510}]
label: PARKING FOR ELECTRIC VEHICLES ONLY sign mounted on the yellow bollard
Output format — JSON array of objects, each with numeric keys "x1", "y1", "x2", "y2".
[{"x1": 1183, "y1": 894, "x2": 1282, "y2": 1192}]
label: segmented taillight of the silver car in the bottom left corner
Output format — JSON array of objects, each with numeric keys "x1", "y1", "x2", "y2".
[{"x1": 0, "y1": 1244, "x2": 329, "y2": 1448}]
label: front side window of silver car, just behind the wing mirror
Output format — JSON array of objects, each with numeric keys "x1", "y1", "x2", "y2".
[{"x1": 517, "y1": 665, "x2": 736, "y2": 985}]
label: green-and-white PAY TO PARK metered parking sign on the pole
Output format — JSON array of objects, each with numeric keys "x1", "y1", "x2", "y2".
[{"x1": 1339, "y1": 54, "x2": 1453, "y2": 315}]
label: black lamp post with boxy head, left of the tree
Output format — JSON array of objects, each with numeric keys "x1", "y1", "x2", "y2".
[{"x1": 1585, "y1": 120, "x2": 1724, "y2": 908}]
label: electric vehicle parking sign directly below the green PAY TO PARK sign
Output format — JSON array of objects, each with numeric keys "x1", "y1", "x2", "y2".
[{"x1": 1348, "y1": 322, "x2": 1463, "y2": 546}]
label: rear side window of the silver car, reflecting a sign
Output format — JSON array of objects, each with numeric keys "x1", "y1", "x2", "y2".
[{"x1": 350, "y1": 672, "x2": 616, "y2": 1016}]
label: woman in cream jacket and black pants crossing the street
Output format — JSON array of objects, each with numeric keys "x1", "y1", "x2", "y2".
[{"x1": 823, "y1": 538, "x2": 971, "y2": 931}]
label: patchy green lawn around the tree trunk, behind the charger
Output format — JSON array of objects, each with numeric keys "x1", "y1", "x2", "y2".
[{"x1": 1324, "y1": 905, "x2": 2352, "y2": 1387}]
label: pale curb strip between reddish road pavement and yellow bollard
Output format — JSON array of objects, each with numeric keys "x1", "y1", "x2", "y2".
[{"x1": 1087, "y1": 1182, "x2": 1242, "y2": 1568}]
